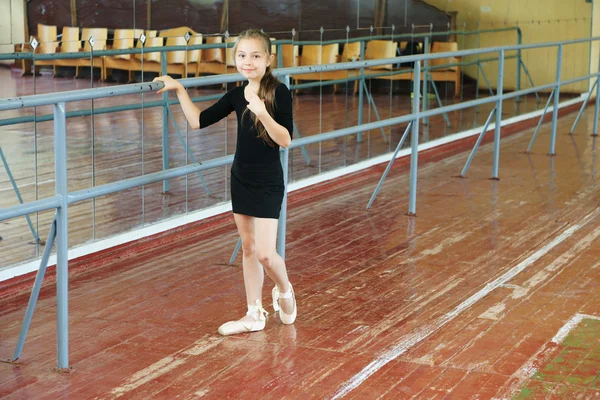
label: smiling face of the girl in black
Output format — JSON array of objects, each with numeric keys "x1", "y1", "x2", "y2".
[{"x1": 235, "y1": 38, "x2": 273, "y2": 82}]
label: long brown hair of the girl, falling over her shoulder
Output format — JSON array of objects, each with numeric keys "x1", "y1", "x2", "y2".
[{"x1": 233, "y1": 29, "x2": 279, "y2": 147}]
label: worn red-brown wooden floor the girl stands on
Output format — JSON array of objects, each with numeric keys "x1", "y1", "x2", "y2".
[{"x1": 0, "y1": 84, "x2": 600, "y2": 400}]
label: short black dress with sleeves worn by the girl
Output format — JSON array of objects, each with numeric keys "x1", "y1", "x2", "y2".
[{"x1": 200, "y1": 82, "x2": 293, "y2": 219}]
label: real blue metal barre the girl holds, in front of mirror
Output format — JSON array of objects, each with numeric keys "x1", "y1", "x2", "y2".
[{"x1": 0, "y1": 37, "x2": 600, "y2": 369}]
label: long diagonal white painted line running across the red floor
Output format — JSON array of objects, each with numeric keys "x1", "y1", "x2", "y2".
[{"x1": 331, "y1": 208, "x2": 600, "y2": 400}]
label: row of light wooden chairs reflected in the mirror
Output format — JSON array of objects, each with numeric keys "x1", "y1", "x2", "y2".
[{"x1": 23, "y1": 24, "x2": 461, "y2": 95}]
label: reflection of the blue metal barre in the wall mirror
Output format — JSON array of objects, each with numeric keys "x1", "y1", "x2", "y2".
[{"x1": 0, "y1": 25, "x2": 528, "y2": 248}]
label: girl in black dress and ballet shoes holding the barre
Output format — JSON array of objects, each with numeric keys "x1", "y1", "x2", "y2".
[{"x1": 155, "y1": 29, "x2": 297, "y2": 335}]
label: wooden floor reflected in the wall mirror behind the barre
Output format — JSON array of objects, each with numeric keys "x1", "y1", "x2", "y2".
[{"x1": 0, "y1": 68, "x2": 565, "y2": 268}]
